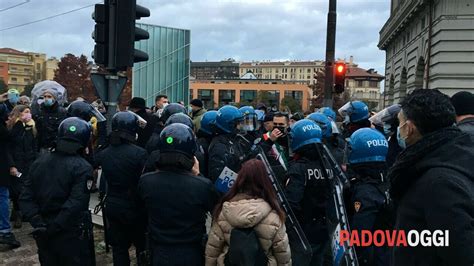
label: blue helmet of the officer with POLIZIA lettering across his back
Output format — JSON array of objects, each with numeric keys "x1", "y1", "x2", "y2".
[{"x1": 290, "y1": 119, "x2": 322, "y2": 151}]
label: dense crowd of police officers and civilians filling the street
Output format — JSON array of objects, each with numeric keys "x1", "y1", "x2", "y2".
[{"x1": 0, "y1": 81, "x2": 474, "y2": 266}]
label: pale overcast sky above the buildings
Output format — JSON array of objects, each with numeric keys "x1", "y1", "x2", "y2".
[{"x1": 0, "y1": 0, "x2": 390, "y2": 73}]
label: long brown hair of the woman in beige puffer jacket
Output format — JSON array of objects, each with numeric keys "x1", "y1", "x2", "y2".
[{"x1": 213, "y1": 159, "x2": 285, "y2": 223}]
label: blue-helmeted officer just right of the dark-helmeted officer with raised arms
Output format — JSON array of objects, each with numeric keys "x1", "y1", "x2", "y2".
[{"x1": 208, "y1": 105, "x2": 245, "y2": 193}]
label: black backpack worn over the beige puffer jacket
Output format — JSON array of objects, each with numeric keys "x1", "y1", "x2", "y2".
[{"x1": 224, "y1": 228, "x2": 268, "y2": 266}]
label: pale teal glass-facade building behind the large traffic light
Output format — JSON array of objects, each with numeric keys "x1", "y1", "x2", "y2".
[{"x1": 132, "y1": 23, "x2": 191, "y2": 106}]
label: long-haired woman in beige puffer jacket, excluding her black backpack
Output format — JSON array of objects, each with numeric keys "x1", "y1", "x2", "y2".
[{"x1": 206, "y1": 159, "x2": 291, "y2": 266}]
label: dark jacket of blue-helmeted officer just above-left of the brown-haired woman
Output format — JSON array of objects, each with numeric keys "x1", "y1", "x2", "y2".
[{"x1": 208, "y1": 134, "x2": 245, "y2": 182}]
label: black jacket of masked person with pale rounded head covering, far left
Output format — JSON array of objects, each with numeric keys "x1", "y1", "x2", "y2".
[{"x1": 34, "y1": 102, "x2": 66, "y2": 151}]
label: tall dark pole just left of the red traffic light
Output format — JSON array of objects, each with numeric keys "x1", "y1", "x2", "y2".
[{"x1": 323, "y1": 0, "x2": 337, "y2": 108}]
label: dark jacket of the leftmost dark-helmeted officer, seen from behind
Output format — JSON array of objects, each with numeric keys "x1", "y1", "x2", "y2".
[{"x1": 20, "y1": 152, "x2": 92, "y2": 233}]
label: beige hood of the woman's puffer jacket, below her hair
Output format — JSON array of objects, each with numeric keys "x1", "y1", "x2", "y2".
[{"x1": 221, "y1": 194, "x2": 272, "y2": 228}]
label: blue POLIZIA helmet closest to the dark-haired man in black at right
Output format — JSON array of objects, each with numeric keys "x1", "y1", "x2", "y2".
[{"x1": 349, "y1": 128, "x2": 388, "y2": 164}]
